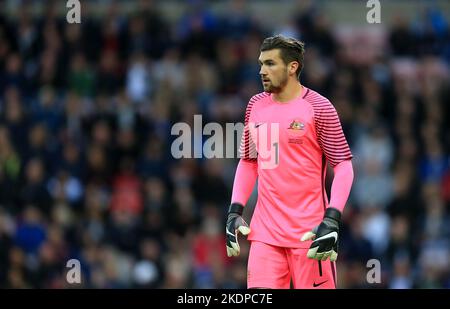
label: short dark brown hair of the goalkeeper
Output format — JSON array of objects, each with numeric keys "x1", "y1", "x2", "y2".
[{"x1": 260, "y1": 35, "x2": 305, "y2": 79}]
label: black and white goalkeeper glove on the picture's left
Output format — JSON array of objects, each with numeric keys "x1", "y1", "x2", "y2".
[{"x1": 226, "y1": 203, "x2": 250, "y2": 257}]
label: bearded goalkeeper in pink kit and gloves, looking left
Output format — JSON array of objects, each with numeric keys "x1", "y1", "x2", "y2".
[{"x1": 226, "y1": 36, "x2": 353, "y2": 289}]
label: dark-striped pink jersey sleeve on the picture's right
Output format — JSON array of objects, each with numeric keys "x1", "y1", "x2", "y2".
[{"x1": 305, "y1": 91, "x2": 353, "y2": 167}]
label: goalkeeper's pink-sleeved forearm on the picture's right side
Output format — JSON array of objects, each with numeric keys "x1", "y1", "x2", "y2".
[{"x1": 330, "y1": 160, "x2": 353, "y2": 212}]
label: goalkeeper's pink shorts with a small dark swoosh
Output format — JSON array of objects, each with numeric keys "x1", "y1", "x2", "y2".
[{"x1": 247, "y1": 241, "x2": 336, "y2": 289}]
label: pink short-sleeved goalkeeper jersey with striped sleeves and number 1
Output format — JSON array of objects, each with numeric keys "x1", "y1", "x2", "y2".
[{"x1": 240, "y1": 87, "x2": 352, "y2": 248}]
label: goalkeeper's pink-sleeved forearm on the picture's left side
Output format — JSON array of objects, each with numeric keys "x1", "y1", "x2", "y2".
[{"x1": 231, "y1": 159, "x2": 258, "y2": 206}]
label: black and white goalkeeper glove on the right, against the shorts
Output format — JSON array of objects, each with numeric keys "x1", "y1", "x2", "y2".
[{"x1": 301, "y1": 207, "x2": 341, "y2": 262}]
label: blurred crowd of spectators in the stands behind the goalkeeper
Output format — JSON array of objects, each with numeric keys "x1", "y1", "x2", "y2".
[{"x1": 0, "y1": 0, "x2": 450, "y2": 288}]
